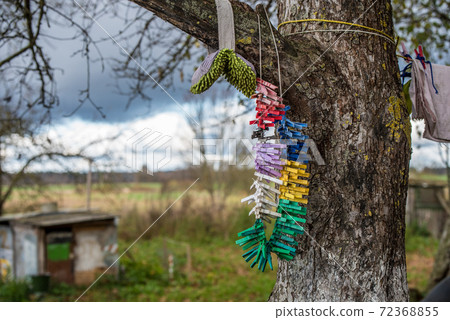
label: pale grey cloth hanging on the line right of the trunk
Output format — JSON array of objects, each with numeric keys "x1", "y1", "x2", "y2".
[{"x1": 409, "y1": 59, "x2": 450, "y2": 142}]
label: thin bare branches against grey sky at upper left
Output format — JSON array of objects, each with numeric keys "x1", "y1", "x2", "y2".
[{"x1": 0, "y1": 0, "x2": 275, "y2": 121}]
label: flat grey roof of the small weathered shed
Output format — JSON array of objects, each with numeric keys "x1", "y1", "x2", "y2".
[{"x1": 0, "y1": 210, "x2": 117, "y2": 227}]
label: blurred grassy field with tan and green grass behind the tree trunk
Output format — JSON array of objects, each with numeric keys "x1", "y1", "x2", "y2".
[{"x1": 0, "y1": 171, "x2": 443, "y2": 301}]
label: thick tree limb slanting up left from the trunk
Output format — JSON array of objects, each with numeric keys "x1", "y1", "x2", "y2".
[{"x1": 131, "y1": 0, "x2": 336, "y2": 109}]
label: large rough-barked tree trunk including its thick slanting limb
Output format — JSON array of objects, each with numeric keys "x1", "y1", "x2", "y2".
[{"x1": 133, "y1": 0, "x2": 411, "y2": 301}]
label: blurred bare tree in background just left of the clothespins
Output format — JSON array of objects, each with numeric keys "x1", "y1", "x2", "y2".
[{"x1": 185, "y1": 88, "x2": 254, "y2": 218}]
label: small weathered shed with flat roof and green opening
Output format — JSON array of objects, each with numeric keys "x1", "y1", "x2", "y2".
[{"x1": 0, "y1": 208, "x2": 118, "y2": 284}]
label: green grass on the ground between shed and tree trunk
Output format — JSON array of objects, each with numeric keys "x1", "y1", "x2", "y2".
[{"x1": 0, "y1": 238, "x2": 276, "y2": 301}]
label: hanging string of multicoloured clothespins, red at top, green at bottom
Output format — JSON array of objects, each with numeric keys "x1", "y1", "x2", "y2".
[{"x1": 236, "y1": 79, "x2": 309, "y2": 271}]
